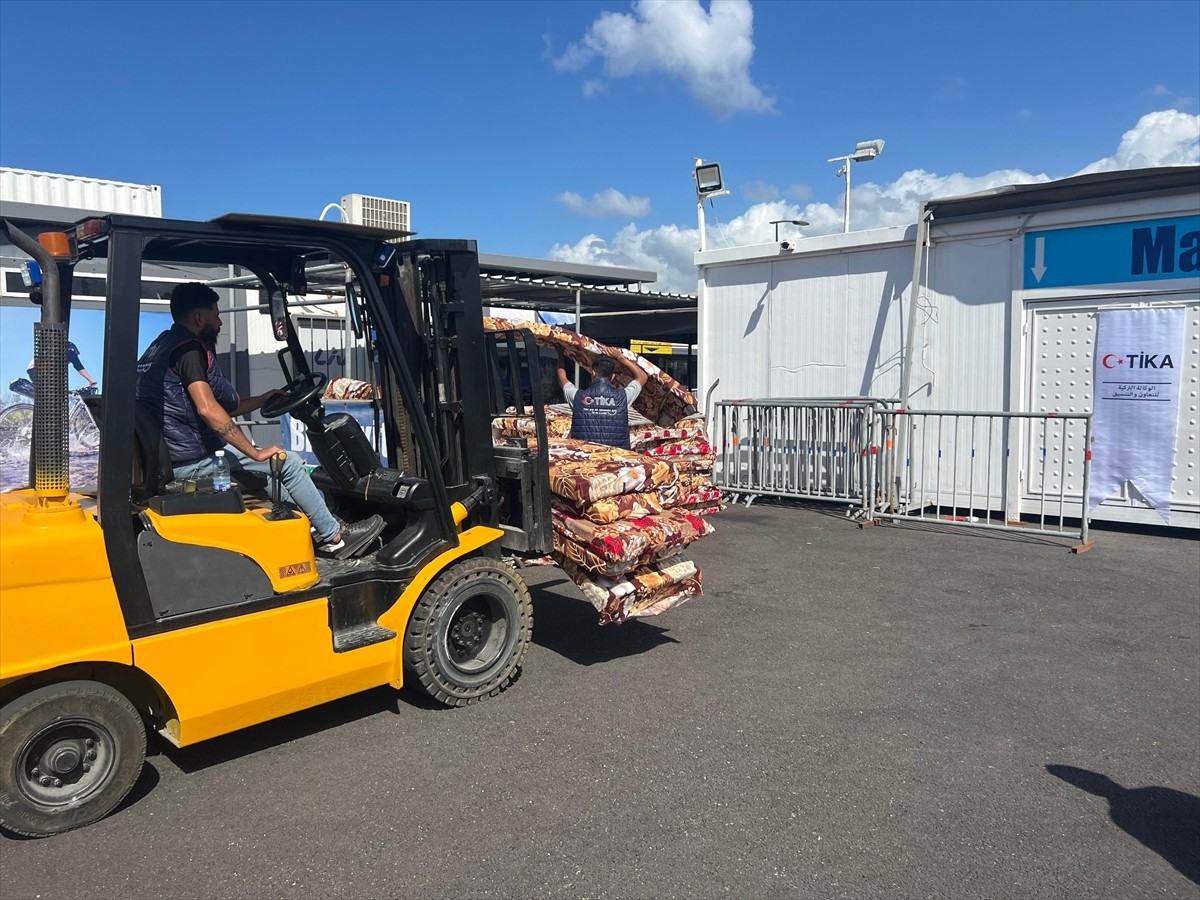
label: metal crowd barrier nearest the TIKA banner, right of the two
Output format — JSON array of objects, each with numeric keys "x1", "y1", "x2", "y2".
[{"x1": 866, "y1": 409, "x2": 1092, "y2": 547}]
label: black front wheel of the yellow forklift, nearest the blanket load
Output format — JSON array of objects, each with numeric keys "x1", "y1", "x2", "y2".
[{"x1": 404, "y1": 559, "x2": 533, "y2": 707}]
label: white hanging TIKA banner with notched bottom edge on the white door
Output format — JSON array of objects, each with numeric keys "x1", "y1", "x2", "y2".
[{"x1": 1087, "y1": 307, "x2": 1187, "y2": 522}]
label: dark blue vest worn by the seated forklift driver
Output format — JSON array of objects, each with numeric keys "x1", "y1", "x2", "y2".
[{"x1": 137, "y1": 324, "x2": 241, "y2": 463}]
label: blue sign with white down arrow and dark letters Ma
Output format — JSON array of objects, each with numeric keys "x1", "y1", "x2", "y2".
[{"x1": 1022, "y1": 216, "x2": 1200, "y2": 290}]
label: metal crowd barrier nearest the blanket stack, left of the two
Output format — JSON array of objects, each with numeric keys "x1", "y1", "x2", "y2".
[{"x1": 710, "y1": 397, "x2": 890, "y2": 505}]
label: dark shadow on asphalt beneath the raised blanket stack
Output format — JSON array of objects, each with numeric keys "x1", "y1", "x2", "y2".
[{"x1": 529, "y1": 578, "x2": 679, "y2": 666}]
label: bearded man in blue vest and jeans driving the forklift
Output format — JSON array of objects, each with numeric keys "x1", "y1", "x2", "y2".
[{"x1": 137, "y1": 282, "x2": 385, "y2": 559}]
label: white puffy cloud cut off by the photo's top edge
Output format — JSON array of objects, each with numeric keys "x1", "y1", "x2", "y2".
[{"x1": 553, "y1": 0, "x2": 775, "y2": 119}]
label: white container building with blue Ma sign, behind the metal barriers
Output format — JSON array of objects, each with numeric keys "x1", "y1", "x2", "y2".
[{"x1": 695, "y1": 167, "x2": 1200, "y2": 528}]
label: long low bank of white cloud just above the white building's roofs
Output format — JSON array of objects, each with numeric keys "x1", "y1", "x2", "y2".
[{"x1": 548, "y1": 109, "x2": 1200, "y2": 292}]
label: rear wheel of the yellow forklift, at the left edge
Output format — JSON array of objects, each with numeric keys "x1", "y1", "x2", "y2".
[{"x1": 0, "y1": 682, "x2": 146, "y2": 838}]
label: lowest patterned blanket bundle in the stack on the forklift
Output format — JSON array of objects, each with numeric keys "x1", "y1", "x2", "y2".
[{"x1": 563, "y1": 559, "x2": 702, "y2": 625}]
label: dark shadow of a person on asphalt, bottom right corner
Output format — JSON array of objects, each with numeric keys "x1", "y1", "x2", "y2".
[{"x1": 1046, "y1": 766, "x2": 1200, "y2": 884}]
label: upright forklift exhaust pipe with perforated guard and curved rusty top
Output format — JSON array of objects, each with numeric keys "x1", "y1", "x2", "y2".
[{"x1": 4, "y1": 222, "x2": 71, "y2": 506}]
